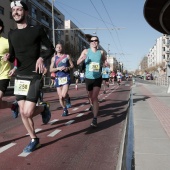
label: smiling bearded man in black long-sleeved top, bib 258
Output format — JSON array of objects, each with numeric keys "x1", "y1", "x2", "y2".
[{"x1": 8, "y1": 1, "x2": 54, "y2": 153}]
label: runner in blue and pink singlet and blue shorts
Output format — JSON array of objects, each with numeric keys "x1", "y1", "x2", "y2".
[{"x1": 50, "y1": 44, "x2": 73, "y2": 116}]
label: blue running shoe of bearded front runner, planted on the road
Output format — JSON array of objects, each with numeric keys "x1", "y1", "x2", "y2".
[{"x1": 23, "y1": 138, "x2": 41, "y2": 153}]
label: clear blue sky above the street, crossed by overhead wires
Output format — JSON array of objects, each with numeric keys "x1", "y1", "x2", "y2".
[{"x1": 55, "y1": 0, "x2": 162, "y2": 71}]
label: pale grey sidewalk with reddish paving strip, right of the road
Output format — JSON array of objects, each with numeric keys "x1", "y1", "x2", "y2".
[{"x1": 132, "y1": 83, "x2": 170, "y2": 170}]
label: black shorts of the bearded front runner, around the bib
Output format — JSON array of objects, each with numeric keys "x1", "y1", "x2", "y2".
[{"x1": 16, "y1": 75, "x2": 42, "y2": 103}]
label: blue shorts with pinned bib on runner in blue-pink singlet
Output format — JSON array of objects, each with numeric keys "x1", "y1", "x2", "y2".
[{"x1": 55, "y1": 75, "x2": 71, "y2": 87}]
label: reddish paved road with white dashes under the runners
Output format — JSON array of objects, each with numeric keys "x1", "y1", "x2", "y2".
[{"x1": 0, "y1": 81, "x2": 131, "y2": 170}]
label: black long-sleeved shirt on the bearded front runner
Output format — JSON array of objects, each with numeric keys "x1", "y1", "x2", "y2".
[{"x1": 8, "y1": 26, "x2": 54, "y2": 75}]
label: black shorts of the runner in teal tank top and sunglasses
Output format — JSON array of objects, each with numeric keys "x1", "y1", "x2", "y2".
[{"x1": 85, "y1": 77, "x2": 102, "y2": 91}]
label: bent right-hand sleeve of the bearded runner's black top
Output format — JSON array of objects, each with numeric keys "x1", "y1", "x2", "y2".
[{"x1": 40, "y1": 26, "x2": 55, "y2": 60}]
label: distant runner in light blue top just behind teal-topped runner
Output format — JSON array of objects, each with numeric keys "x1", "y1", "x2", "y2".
[{"x1": 102, "y1": 62, "x2": 110, "y2": 94}]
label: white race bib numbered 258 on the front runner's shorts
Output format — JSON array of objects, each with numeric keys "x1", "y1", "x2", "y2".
[{"x1": 14, "y1": 79, "x2": 31, "y2": 96}]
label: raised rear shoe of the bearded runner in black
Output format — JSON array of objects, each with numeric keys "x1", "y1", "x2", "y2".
[{"x1": 40, "y1": 102, "x2": 51, "y2": 124}]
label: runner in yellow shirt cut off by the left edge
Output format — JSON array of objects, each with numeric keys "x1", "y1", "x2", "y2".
[{"x1": 0, "y1": 19, "x2": 17, "y2": 109}]
